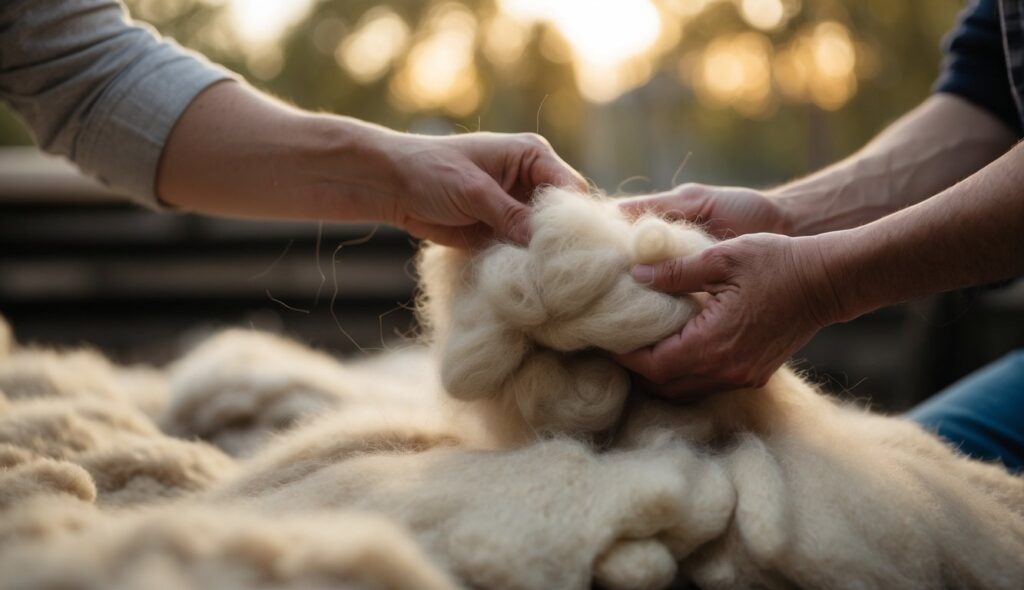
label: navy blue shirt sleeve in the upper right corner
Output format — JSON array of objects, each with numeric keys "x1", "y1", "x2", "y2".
[{"x1": 935, "y1": 0, "x2": 1024, "y2": 136}]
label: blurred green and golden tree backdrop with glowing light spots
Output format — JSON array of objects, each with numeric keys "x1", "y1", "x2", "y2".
[{"x1": 0, "y1": 0, "x2": 963, "y2": 192}]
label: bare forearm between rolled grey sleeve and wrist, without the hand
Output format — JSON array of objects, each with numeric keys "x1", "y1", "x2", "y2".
[{"x1": 157, "y1": 82, "x2": 393, "y2": 221}]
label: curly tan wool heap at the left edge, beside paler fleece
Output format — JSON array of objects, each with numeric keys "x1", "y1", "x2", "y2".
[{"x1": 0, "y1": 340, "x2": 233, "y2": 507}]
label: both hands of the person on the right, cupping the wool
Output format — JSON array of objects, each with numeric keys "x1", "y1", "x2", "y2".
[{"x1": 616, "y1": 184, "x2": 842, "y2": 399}]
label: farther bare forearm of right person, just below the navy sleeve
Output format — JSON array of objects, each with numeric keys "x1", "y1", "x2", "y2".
[{"x1": 771, "y1": 94, "x2": 1015, "y2": 236}]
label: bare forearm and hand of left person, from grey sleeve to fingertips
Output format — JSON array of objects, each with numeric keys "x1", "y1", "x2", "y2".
[{"x1": 155, "y1": 82, "x2": 587, "y2": 247}]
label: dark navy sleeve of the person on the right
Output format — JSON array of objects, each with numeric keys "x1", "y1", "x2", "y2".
[{"x1": 933, "y1": 0, "x2": 1022, "y2": 135}]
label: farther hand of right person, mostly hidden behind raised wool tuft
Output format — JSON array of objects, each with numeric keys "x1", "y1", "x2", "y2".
[{"x1": 622, "y1": 183, "x2": 792, "y2": 240}]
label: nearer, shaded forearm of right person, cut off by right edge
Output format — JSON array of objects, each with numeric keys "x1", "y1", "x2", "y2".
[{"x1": 815, "y1": 140, "x2": 1024, "y2": 321}]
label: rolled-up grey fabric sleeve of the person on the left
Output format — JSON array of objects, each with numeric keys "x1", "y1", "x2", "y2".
[{"x1": 0, "y1": 0, "x2": 233, "y2": 207}]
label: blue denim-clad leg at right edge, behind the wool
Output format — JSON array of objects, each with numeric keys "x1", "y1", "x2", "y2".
[{"x1": 906, "y1": 349, "x2": 1024, "y2": 471}]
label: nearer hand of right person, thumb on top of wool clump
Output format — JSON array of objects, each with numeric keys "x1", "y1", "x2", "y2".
[{"x1": 616, "y1": 234, "x2": 842, "y2": 398}]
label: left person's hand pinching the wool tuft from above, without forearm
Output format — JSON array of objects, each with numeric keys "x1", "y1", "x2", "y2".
[{"x1": 387, "y1": 133, "x2": 587, "y2": 247}]
